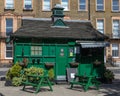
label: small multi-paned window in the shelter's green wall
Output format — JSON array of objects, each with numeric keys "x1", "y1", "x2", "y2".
[{"x1": 31, "y1": 46, "x2": 42, "y2": 56}]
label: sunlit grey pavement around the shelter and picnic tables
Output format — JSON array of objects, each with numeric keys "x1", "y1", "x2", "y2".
[{"x1": 0, "y1": 67, "x2": 120, "y2": 96}]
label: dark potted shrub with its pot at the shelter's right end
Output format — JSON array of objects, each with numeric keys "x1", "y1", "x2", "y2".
[{"x1": 104, "y1": 69, "x2": 114, "y2": 83}]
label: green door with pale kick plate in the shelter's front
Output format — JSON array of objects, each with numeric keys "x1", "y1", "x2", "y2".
[{"x1": 55, "y1": 46, "x2": 67, "y2": 80}]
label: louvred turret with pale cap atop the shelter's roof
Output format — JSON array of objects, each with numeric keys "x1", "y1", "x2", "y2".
[{"x1": 51, "y1": 4, "x2": 65, "y2": 22}]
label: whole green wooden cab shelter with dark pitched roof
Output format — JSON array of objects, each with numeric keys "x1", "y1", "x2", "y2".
[{"x1": 11, "y1": 5, "x2": 107, "y2": 81}]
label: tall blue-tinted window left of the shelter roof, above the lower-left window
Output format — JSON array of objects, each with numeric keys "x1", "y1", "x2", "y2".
[{"x1": 6, "y1": 18, "x2": 13, "y2": 36}]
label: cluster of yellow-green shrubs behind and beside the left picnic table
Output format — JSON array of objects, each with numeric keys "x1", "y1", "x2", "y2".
[{"x1": 6, "y1": 63, "x2": 44, "y2": 86}]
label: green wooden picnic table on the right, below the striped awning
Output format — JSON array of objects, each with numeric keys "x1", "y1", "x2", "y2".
[{"x1": 70, "y1": 74, "x2": 100, "y2": 91}]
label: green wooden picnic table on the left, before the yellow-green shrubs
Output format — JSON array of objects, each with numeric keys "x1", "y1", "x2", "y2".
[{"x1": 22, "y1": 71, "x2": 53, "y2": 93}]
